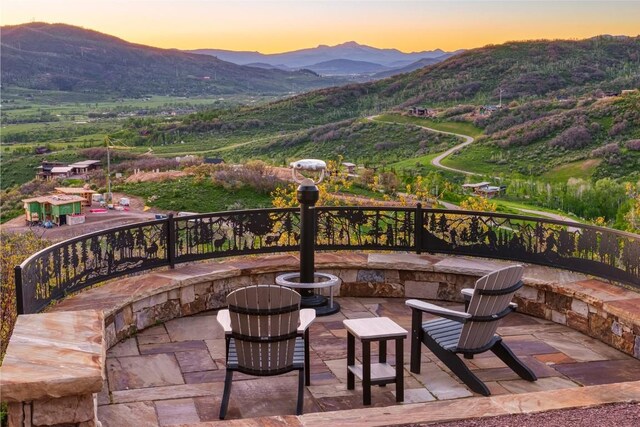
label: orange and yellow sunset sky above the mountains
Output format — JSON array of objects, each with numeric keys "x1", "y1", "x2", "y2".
[{"x1": 0, "y1": 0, "x2": 640, "y2": 53}]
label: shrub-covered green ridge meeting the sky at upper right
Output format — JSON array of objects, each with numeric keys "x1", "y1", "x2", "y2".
[{"x1": 185, "y1": 36, "x2": 640, "y2": 128}]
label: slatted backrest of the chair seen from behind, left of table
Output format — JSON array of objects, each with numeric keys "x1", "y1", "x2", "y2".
[{"x1": 227, "y1": 285, "x2": 300, "y2": 375}]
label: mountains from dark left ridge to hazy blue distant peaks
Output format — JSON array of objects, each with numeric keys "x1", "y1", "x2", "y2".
[{"x1": 0, "y1": 22, "x2": 456, "y2": 96}]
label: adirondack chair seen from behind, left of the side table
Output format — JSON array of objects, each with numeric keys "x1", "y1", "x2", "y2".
[{"x1": 217, "y1": 285, "x2": 315, "y2": 419}]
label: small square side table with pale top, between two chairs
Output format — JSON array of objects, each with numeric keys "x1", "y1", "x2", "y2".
[{"x1": 342, "y1": 317, "x2": 407, "y2": 405}]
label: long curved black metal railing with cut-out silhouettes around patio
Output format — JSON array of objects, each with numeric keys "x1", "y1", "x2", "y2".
[{"x1": 15, "y1": 205, "x2": 640, "y2": 314}]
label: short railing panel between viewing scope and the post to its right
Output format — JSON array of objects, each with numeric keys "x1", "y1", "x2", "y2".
[{"x1": 316, "y1": 207, "x2": 416, "y2": 251}]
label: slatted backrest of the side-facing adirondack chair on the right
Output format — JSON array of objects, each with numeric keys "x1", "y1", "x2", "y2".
[{"x1": 458, "y1": 265, "x2": 524, "y2": 350}]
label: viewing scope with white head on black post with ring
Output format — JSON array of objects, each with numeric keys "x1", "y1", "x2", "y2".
[{"x1": 276, "y1": 159, "x2": 341, "y2": 316}]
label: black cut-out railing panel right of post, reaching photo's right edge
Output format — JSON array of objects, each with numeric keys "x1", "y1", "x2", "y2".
[{"x1": 421, "y1": 209, "x2": 640, "y2": 286}]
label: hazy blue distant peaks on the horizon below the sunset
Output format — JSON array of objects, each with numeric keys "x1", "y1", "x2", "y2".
[{"x1": 189, "y1": 41, "x2": 463, "y2": 78}]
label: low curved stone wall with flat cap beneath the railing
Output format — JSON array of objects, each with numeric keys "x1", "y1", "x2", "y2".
[{"x1": 0, "y1": 253, "x2": 640, "y2": 427}]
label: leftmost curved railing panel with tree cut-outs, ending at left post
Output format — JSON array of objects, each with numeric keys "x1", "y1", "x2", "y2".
[{"x1": 16, "y1": 220, "x2": 169, "y2": 313}]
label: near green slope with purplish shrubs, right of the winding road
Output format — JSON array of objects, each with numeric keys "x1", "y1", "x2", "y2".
[{"x1": 446, "y1": 91, "x2": 640, "y2": 181}]
